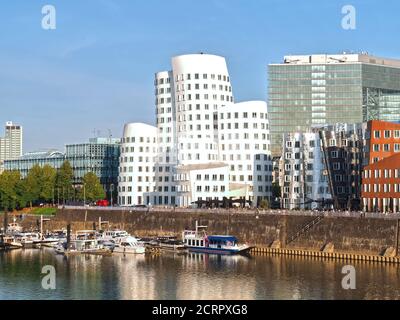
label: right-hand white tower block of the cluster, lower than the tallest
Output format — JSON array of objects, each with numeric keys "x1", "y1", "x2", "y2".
[{"x1": 218, "y1": 101, "x2": 272, "y2": 204}]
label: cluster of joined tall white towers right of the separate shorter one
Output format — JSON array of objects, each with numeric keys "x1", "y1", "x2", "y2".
[{"x1": 120, "y1": 54, "x2": 272, "y2": 206}]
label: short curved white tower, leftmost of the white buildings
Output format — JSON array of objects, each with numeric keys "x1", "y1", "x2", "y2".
[{"x1": 118, "y1": 123, "x2": 157, "y2": 206}]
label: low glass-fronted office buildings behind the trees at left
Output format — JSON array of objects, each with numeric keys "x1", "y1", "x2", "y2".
[{"x1": 4, "y1": 138, "x2": 120, "y2": 200}]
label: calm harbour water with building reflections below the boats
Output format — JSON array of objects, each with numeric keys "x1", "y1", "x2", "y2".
[{"x1": 0, "y1": 249, "x2": 400, "y2": 300}]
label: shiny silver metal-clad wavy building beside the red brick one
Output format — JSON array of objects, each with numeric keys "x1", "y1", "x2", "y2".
[{"x1": 280, "y1": 124, "x2": 365, "y2": 210}]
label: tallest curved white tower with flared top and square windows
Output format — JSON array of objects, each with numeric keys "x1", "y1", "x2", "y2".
[{"x1": 172, "y1": 54, "x2": 233, "y2": 165}]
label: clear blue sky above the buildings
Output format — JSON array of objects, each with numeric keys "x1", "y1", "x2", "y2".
[{"x1": 0, "y1": 0, "x2": 400, "y2": 151}]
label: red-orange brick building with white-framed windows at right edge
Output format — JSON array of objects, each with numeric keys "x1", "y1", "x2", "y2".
[{"x1": 361, "y1": 120, "x2": 400, "y2": 212}]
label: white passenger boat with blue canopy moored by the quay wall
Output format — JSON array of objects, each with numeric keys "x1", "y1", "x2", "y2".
[{"x1": 182, "y1": 221, "x2": 253, "y2": 254}]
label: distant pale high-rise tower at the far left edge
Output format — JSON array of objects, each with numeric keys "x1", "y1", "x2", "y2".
[{"x1": 0, "y1": 121, "x2": 23, "y2": 161}]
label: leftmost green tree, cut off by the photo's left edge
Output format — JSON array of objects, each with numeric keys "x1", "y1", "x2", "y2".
[{"x1": 0, "y1": 171, "x2": 21, "y2": 211}]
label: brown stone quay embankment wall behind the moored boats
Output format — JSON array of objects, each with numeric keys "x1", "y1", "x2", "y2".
[{"x1": 8, "y1": 209, "x2": 397, "y2": 262}]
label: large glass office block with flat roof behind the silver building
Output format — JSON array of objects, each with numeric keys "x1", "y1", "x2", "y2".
[{"x1": 268, "y1": 54, "x2": 400, "y2": 156}]
